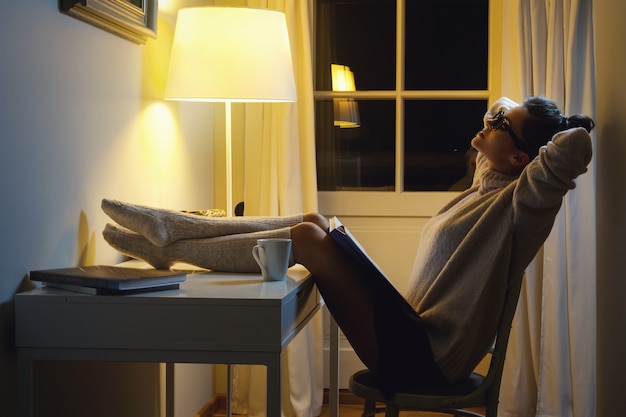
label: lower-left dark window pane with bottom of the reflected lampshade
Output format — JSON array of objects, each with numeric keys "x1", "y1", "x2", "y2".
[{"x1": 315, "y1": 99, "x2": 396, "y2": 191}]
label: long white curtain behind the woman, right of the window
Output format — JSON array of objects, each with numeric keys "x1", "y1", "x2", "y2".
[{"x1": 498, "y1": 0, "x2": 596, "y2": 417}]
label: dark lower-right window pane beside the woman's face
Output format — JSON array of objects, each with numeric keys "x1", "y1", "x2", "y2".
[{"x1": 404, "y1": 100, "x2": 487, "y2": 191}]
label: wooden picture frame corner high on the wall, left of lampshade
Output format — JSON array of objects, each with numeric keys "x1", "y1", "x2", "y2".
[{"x1": 59, "y1": 0, "x2": 157, "y2": 44}]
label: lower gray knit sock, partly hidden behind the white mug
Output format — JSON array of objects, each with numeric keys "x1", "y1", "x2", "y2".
[{"x1": 102, "y1": 224, "x2": 294, "y2": 272}]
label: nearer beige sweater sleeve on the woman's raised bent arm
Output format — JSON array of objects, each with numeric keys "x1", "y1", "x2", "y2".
[{"x1": 513, "y1": 128, "x2": 592, "y2": 262}]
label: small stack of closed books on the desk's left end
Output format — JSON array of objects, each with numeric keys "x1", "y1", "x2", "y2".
[{"x1": 30, "y1": 265, "x2": 187, "y2": 294}]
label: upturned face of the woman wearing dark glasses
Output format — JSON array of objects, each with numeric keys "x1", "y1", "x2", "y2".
[{"x1": 472, "y1": 106, "x2": 530, "y2": 174}]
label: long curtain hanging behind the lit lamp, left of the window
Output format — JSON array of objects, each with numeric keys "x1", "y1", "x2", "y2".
[{"x1": 216, "y1": 0, "x2": 323, "y2": 417}]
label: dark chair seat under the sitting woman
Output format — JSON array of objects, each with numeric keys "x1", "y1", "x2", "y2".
[{"x1": 349, "y1": 369, "x2": 485, "y2": 408}]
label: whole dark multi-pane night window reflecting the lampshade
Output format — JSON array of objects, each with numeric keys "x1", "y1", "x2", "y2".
[{"x1": 315, "y1": 0, "x2": 494, "y2": 198}]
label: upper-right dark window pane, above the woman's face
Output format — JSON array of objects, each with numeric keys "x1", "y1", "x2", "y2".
[{"x1": 405, "y1": 0, "x2": 489, "y2": 90}]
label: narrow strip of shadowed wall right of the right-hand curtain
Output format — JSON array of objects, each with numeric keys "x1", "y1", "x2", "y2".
[{"x1": 594, "y1": 0, "x2": 626, "y2": 417}]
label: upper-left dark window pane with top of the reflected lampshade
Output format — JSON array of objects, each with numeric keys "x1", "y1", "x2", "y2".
[{"x1": 316, "y1": 0, "x2": 396, "y2": 91}]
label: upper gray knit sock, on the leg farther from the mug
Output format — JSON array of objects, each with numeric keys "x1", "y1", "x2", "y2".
[{"x1": 102, "y1": 199, "x2": 303, "y2": 247}]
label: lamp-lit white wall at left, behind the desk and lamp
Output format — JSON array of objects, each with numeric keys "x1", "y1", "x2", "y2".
[{"x1": 0, "y1": 0, "x2": 213, "y2": 416}]
